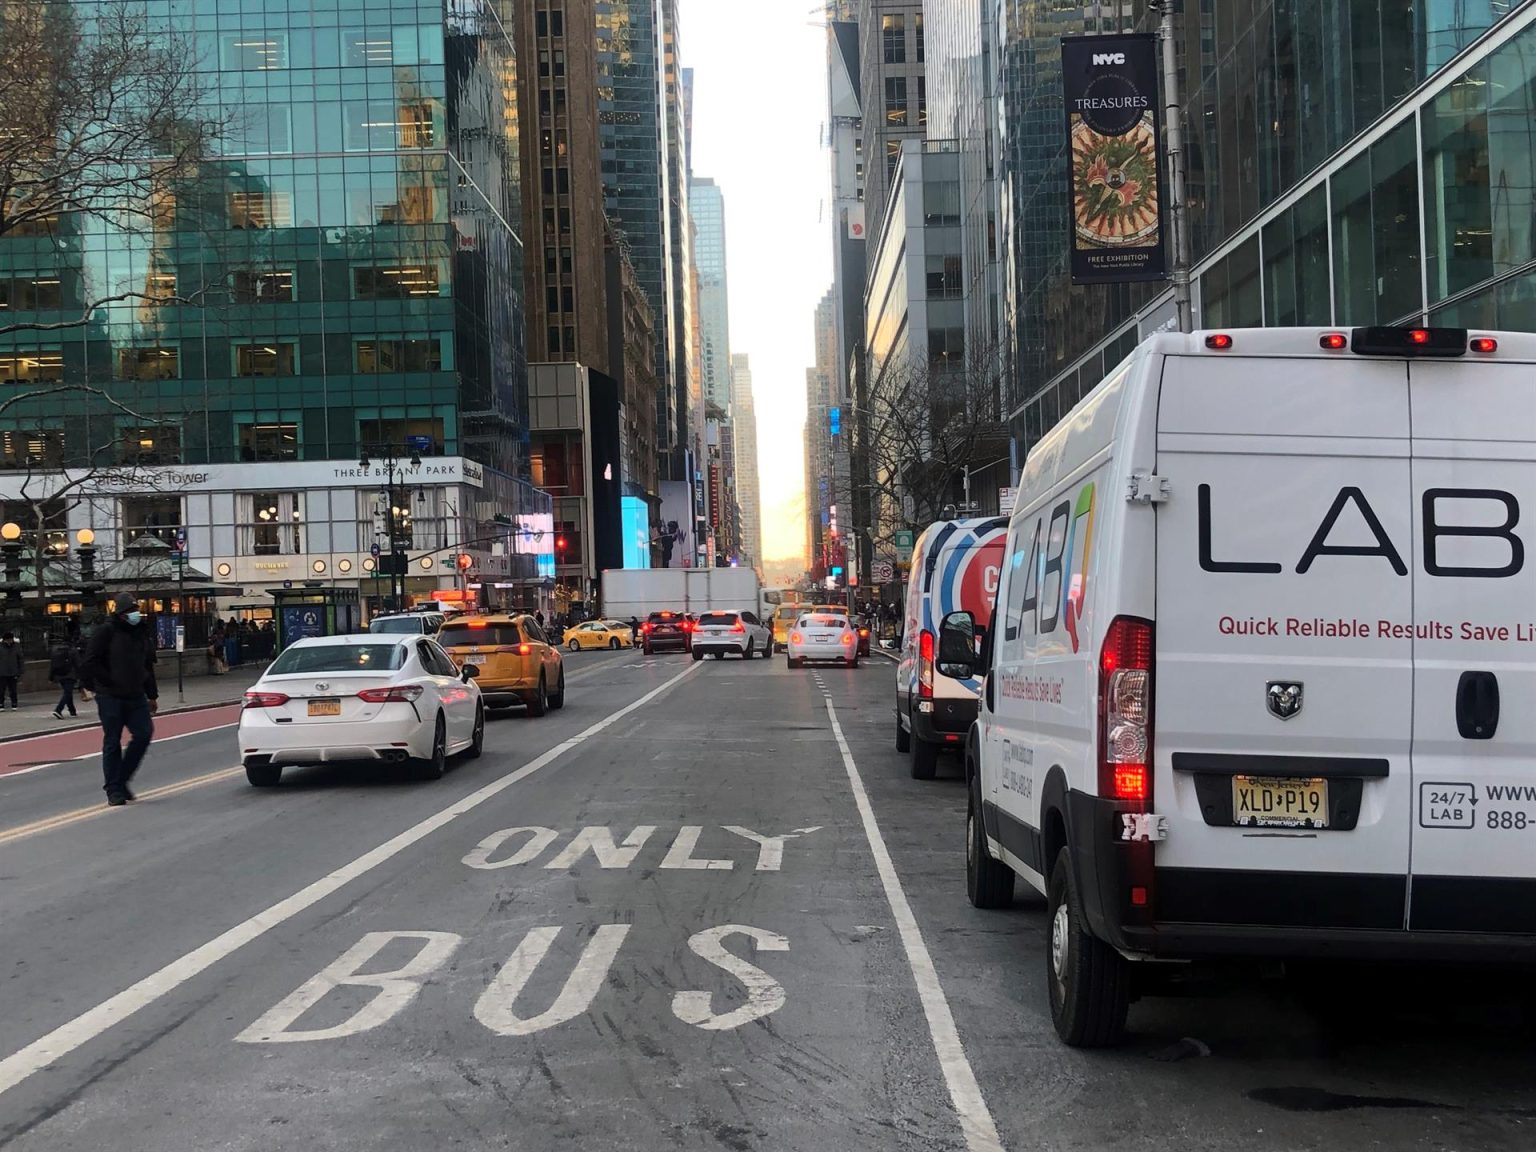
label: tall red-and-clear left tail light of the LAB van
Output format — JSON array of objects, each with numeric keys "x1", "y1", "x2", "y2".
[{"x1": 1098, "y1": 616, "x2": 1154, "y2": 813}]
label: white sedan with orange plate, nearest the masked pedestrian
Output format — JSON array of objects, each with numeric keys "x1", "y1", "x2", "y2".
[{"x1": 240, "y1": 634, "x2": 485, "y2": 788}]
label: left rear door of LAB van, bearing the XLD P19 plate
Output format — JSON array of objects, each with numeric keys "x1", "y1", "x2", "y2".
[{"x1": 1152, "y1": 353, "x2": 1413, "y2": 929}]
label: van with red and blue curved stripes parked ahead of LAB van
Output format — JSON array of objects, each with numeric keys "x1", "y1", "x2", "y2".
[{"x1": 895, "y1": 516, "x2": 1008, "y2": 780}]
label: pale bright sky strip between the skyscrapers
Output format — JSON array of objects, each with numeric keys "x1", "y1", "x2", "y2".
[{"x1": 680, "y1": 0, "x2": 833, "y2": 571}]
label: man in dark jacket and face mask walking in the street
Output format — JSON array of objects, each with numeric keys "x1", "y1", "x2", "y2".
[{"x1": 80, "y1": 596, "x2": 160, "y2": 808}]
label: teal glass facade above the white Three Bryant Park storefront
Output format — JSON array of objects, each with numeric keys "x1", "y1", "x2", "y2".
[{"x1": 0, "y1": 0, "x2": 527, "y2": 476}]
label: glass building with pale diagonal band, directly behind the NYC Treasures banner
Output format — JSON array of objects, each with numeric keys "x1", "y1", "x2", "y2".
[{"x1": 992, "y1": 0, "x2": 1536, "y2": 460}]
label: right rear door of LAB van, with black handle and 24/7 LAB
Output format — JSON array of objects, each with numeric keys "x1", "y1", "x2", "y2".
[{"x1": 1407, "y1": 358, "x2": 1536, "y2": 934}]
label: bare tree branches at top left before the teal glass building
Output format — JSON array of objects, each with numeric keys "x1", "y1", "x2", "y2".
[{"x1": 0, "y1": 0, "x2": 226, "y2": 335}]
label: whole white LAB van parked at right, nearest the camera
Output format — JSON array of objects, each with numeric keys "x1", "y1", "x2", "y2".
[{"x1": 938, "y1": 329, "x2": 1536, "y2": 1044}]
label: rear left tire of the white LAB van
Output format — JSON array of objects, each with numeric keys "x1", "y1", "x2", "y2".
[{"x1": 1046, "y1": 848, "x2": 1130, "y2": 1048}]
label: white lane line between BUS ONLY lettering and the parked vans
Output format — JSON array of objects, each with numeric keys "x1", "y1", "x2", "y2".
[{"x1": 826, "y1": 700, "x2": 1003, "y2": 1152}]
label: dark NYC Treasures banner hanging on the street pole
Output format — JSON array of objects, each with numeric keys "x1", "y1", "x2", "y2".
[{"x1": 1061, "y1": 34, "x2": 1167, "y2": 284}]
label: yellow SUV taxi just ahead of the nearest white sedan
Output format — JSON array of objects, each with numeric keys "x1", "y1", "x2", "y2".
[{"x1": 438, "y1": 614, "x2": 565, "y2": 716}]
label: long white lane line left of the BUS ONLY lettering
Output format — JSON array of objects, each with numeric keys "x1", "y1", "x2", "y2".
[{"x1": 0, "y1": 665, "x2": 699, "y2": 1094}]
